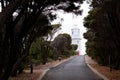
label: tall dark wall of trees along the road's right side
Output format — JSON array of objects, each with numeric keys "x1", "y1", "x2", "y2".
[{"x1": 84, "y1": 0, "x2": 120, "y2": 69}]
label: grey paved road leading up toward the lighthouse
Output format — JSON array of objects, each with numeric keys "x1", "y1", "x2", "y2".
[{"x1": 42, "y1": 56, "x2": 103, "y2": 80}]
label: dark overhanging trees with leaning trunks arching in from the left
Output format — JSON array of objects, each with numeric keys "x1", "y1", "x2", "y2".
[{"x1": 0, "y1": 0, "x2": 84, "y2": 80}]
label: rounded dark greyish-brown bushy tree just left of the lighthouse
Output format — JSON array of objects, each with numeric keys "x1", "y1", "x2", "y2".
[{"x1": 51, "y1": 34, "x2": 71, "y2": 59}]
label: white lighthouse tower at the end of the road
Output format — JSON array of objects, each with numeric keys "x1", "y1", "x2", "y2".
[{"x1": 71, "y1": 27, "x2": 81, "y2": 54}]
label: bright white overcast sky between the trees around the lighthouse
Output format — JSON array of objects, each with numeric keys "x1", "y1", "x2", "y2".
[{"x1": 52, "y1": 1, "x2": 90, "y2": 55}]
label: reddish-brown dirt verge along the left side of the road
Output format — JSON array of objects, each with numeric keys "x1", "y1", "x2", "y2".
[{"x1": 9, "y1": 58, "x2": 69, "y2": 80}]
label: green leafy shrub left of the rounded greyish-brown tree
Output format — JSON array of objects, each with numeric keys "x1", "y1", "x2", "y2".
[{"x1": 30, "y1": 37, "x2": 53, "y2": 64}]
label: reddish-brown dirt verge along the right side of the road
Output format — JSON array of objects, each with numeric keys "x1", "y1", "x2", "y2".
[{"x1": 85, "y1": 55, "x2": 120, "y2": 80}]
